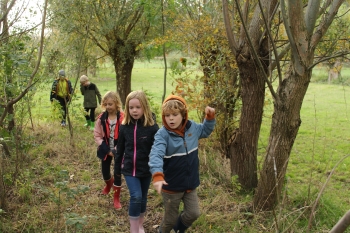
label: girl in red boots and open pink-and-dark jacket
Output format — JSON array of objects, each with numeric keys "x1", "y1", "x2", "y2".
[{"x1": 94, "y1": 91, "x2": 124, "y2": 209}]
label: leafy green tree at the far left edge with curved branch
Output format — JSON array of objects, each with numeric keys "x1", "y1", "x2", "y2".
[{"x1": 0, "y1": 0, "x2": 47, "y2": 131}]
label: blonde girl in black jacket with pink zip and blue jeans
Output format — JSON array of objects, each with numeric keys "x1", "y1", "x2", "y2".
[{"x1": 115, "y1": 91, "x2": 159, "y2": 233}]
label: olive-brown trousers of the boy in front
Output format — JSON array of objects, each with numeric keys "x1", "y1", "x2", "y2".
[{"x1": 160, "y1": 189, "x2": 200, "y2": 233}]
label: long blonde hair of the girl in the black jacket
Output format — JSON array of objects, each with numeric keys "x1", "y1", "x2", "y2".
[{"x1": 122, "y1": 91, "x2": 155, "y2": 127}]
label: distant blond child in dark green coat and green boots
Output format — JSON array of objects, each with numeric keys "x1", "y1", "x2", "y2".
[{"x1": 80, "y1": 75, "x2": 101, "y2": 130}]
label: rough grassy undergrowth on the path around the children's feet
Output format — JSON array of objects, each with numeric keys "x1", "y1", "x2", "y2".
[{"x1": 0, "y1": 118, "x2": 348, "y2": 233}]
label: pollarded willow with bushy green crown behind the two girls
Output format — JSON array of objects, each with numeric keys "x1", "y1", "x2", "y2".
[{"x1": 50, "y1": 0, "x2": 160, "y2": 103}]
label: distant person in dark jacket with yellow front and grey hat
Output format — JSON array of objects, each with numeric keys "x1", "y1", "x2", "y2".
[{"x1": 50, "y1": 70, "x2": 73, "y2": 127}]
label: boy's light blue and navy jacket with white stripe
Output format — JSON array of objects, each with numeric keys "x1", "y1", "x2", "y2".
[{"x1": 149, "y1": 109, "x2": 215, "y2": 192}]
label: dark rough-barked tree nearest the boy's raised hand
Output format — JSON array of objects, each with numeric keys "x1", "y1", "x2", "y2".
[{"x1": 222, "y1": 0, "x2": 280, "y2": 190}]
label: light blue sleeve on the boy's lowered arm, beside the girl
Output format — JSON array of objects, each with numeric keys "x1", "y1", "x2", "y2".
[{"x1": 148, "y1": 128, "x2": 169, "y2": 175}]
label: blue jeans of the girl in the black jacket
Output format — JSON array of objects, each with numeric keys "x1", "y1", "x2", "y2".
[{"x1": 124, "y1": 176, "x2": 152, "y2": 217}]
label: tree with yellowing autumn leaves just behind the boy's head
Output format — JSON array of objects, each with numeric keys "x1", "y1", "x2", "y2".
[{"x1": 154, "y1": 0, "x2": 240, "y2": 153}]
